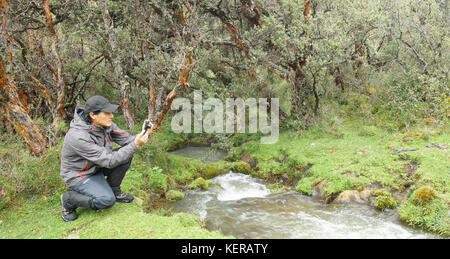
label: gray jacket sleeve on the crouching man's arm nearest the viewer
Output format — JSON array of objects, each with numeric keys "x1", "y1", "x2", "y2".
[{"x1": 68, "y1": 132, "x2": 138, "y2": 171}]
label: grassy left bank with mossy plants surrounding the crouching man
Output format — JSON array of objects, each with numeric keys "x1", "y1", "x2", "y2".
[{"x1": 0, "y1": 119, "x2": 233, "y2": 239}]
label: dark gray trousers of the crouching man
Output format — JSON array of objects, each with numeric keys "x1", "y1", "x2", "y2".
[{"x1": 71, "y1": 156, "x2": 133, "y2": 210}]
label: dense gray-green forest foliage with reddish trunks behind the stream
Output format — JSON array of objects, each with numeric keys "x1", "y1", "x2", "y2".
[{"x1": 2, "y1": 0, "x2": 450, "y2": 156}]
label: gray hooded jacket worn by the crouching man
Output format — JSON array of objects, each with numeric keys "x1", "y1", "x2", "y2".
[{"x1": 60, "y1": 106, "x2": 138, "y2": 187}]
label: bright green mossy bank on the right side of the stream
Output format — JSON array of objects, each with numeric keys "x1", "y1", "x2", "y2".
[{"x1": 230, "y1": 121, "x2": 450, "y2": 236}]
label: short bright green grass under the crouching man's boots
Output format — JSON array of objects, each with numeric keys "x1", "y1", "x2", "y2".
[{"x1": 0, "y1": 195, "x2": 231, "y2": 239}]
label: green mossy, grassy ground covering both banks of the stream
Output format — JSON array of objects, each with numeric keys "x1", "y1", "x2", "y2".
[{"x1": 0, "y1": 115, "x2": 450, "y2": 238}]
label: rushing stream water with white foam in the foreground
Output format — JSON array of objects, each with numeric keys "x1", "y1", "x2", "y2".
[{"x1": 172, "y1": 147, "x2": 439, "y2": 239}]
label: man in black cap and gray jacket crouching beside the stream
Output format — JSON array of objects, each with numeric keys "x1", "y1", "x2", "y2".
[{"x1": 60, "y1": 96, "x2": 152, "y2": 221}]
